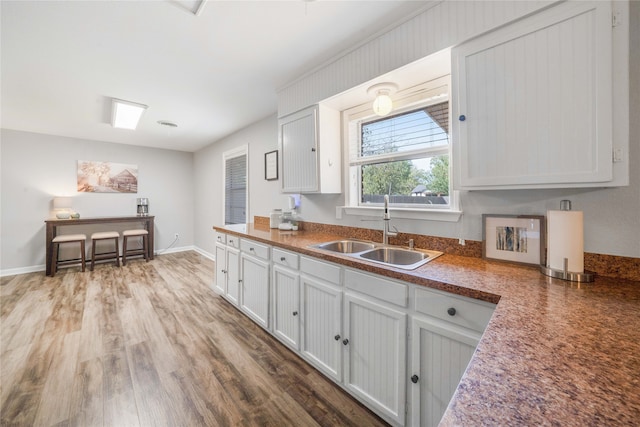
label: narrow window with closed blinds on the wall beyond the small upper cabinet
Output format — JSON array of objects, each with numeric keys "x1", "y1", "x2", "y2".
[{"x1": 224, "y1": 154, "x2": 247, "y2": 224}]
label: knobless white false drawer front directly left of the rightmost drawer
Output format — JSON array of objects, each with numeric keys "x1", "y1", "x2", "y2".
[{"x1": 344, "y1": 270, "x2": 409, "y2": 307}]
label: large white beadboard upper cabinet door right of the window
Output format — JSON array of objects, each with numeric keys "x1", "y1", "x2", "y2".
[{"x1": 452, "y1": 1, "x2": 613, "y2": 189}]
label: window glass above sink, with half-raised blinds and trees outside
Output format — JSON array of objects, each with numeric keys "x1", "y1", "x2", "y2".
[{"x1": 360, "y1": 102, "x2": 449, "y2": 204}]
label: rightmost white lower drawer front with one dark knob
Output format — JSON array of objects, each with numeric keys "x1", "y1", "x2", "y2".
[{"x1": 416, "y1": 289, "x2": 495, "y2": 332}]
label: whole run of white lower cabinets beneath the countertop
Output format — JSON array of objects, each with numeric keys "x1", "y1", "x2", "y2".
[{"x1": 215, "y1": 236, "x2": 495, "y2": 426}]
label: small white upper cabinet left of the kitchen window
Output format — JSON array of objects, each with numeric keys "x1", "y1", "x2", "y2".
[{"x1": 278, "y1": 105, "x2": 342, "y2": 193}]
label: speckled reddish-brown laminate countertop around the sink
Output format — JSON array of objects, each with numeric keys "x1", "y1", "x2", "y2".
[{"x1": 214, "y1": 224, "x2": 640, "y2": 426}]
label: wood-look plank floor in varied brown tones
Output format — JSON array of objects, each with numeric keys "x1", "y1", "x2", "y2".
[{"x1": 0, "y1": 252, "x2": 385, "y2": 426}]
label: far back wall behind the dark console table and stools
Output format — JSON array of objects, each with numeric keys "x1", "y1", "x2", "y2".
[{"x1": 0, "y1": 129, "x2": 194, "y2": 275}]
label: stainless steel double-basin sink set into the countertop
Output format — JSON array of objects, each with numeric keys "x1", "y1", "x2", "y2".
[{"x1": 311, "y1": 239, "x2": 442, "y2": 270}]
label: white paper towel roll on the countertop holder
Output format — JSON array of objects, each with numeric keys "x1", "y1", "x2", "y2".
[{"x1": 547, "y1": 211, "x2": 584, "y2": 273}]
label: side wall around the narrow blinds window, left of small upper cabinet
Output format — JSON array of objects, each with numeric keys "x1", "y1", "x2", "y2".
[{"x1": 194, "y1": 114, "x2": 286, "y2": 256}]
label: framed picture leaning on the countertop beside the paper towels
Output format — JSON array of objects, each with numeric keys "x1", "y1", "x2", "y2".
[{"x1": 482, "y1": 214, "x2": 546, "y2": 265}]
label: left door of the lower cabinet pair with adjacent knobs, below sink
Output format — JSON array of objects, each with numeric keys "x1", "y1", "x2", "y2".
[{"x1": 300, "y1": 274, "x2": 343, "y2": 381}]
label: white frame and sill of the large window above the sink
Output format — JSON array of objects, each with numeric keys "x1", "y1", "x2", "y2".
[{"x1": 336, "y1": 75, "x2": 462, "y2": 222}]
